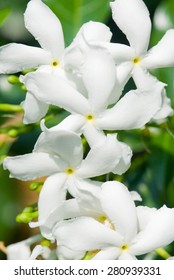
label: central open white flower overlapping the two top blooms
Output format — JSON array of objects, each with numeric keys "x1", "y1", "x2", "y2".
[{"x1": 24, "y1": 46, "x2": 163, "y2": 143}]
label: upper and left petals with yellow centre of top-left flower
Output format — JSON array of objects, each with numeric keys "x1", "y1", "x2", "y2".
[{"x1": 0, "y1": 0, "x2": 64, "y2": 74}]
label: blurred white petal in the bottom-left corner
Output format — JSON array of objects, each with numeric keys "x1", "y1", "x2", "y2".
[{"x1": 7, "y1": 241, "x2": 31, "y2": 260}]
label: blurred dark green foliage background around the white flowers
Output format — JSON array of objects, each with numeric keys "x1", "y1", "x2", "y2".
[{"x1": 0, "y1": 0, "x2": 174, "y2": 259}]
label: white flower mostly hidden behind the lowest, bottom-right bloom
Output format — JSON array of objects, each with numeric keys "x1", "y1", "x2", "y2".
[{"x1": 36, "y1": 181, "x2": 142, "y2": 243}]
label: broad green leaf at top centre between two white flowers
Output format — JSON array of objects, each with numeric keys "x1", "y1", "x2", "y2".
[{"x1": 45, "y1": 0, "x2": 110, "y2": 44}]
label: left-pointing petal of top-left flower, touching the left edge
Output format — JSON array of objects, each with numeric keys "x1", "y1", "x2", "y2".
[{"x1": 0, "y1": 43, "x2": 51, "y2": 74}]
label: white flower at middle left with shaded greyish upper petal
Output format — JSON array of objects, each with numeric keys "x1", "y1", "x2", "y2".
[{"x1": 4, "y1": 130, "x2": 132, "y2": 230}]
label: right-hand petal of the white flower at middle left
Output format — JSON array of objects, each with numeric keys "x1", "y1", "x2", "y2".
[{"x1": 77, "y1": 134, "x2": 121, "y2": 178}]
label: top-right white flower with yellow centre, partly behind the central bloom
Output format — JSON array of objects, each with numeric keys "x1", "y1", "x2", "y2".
[{"x1": 101, "y1": 0, "x2": 174, "y2": 119}]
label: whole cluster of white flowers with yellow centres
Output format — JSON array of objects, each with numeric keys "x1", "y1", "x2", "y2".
[{"x1": 0, "y1": 0, "x2": 174, "y2": 260}]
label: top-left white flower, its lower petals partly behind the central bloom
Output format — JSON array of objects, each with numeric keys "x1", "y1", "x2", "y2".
[{"x1": 0, "y1": 0, "x2": 111, "y2": 123}]
